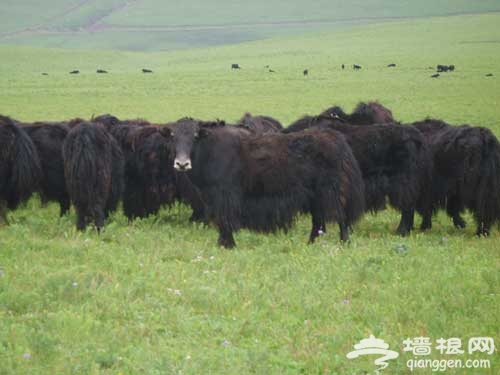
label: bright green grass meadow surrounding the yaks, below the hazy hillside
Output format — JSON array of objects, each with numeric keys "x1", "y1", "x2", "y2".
[{"x1": 0, "y1": 14, "x2": 500, "y2": 374}]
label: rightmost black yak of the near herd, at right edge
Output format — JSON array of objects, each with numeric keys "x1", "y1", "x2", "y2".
[{"x1": 412, "y1": 119, "x2": 500, "y2": 236}]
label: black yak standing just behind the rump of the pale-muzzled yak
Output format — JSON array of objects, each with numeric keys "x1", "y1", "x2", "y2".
[{"x1": 284, "y1": 115, "x2": 432, "y2": 236}]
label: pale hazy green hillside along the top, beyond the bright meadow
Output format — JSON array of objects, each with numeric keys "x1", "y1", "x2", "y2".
[{"x1": 0, "y1": 0, "x2": 500, "y2": 51}]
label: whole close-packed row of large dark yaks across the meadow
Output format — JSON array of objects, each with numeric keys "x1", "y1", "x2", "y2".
[{"x1": 0, "y1": 102, "x2": 500, "y2": 248}]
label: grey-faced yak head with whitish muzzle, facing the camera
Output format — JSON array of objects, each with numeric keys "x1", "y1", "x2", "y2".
[{"x1": 161, "y1": 118, "x2": 224, "y2": 172}]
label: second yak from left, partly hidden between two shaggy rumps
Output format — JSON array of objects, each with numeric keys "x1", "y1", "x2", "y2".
[{"x1": 21, "y1": 122, "x2": 70, "y2": 216}]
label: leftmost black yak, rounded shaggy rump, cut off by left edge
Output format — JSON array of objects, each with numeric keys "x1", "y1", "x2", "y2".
[{"x1": 0, "y1": 115, "x2": 42, "y2": 224}]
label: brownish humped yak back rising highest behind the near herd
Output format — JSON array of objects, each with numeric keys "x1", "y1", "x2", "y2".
[{"x1": 321, "y1": 102, "x2": 394, "y2": 125}]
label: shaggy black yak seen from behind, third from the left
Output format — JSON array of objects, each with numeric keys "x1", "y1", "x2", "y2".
[{"x1": 63, "y1": 121, "x2": 124, "y2": 231}]
